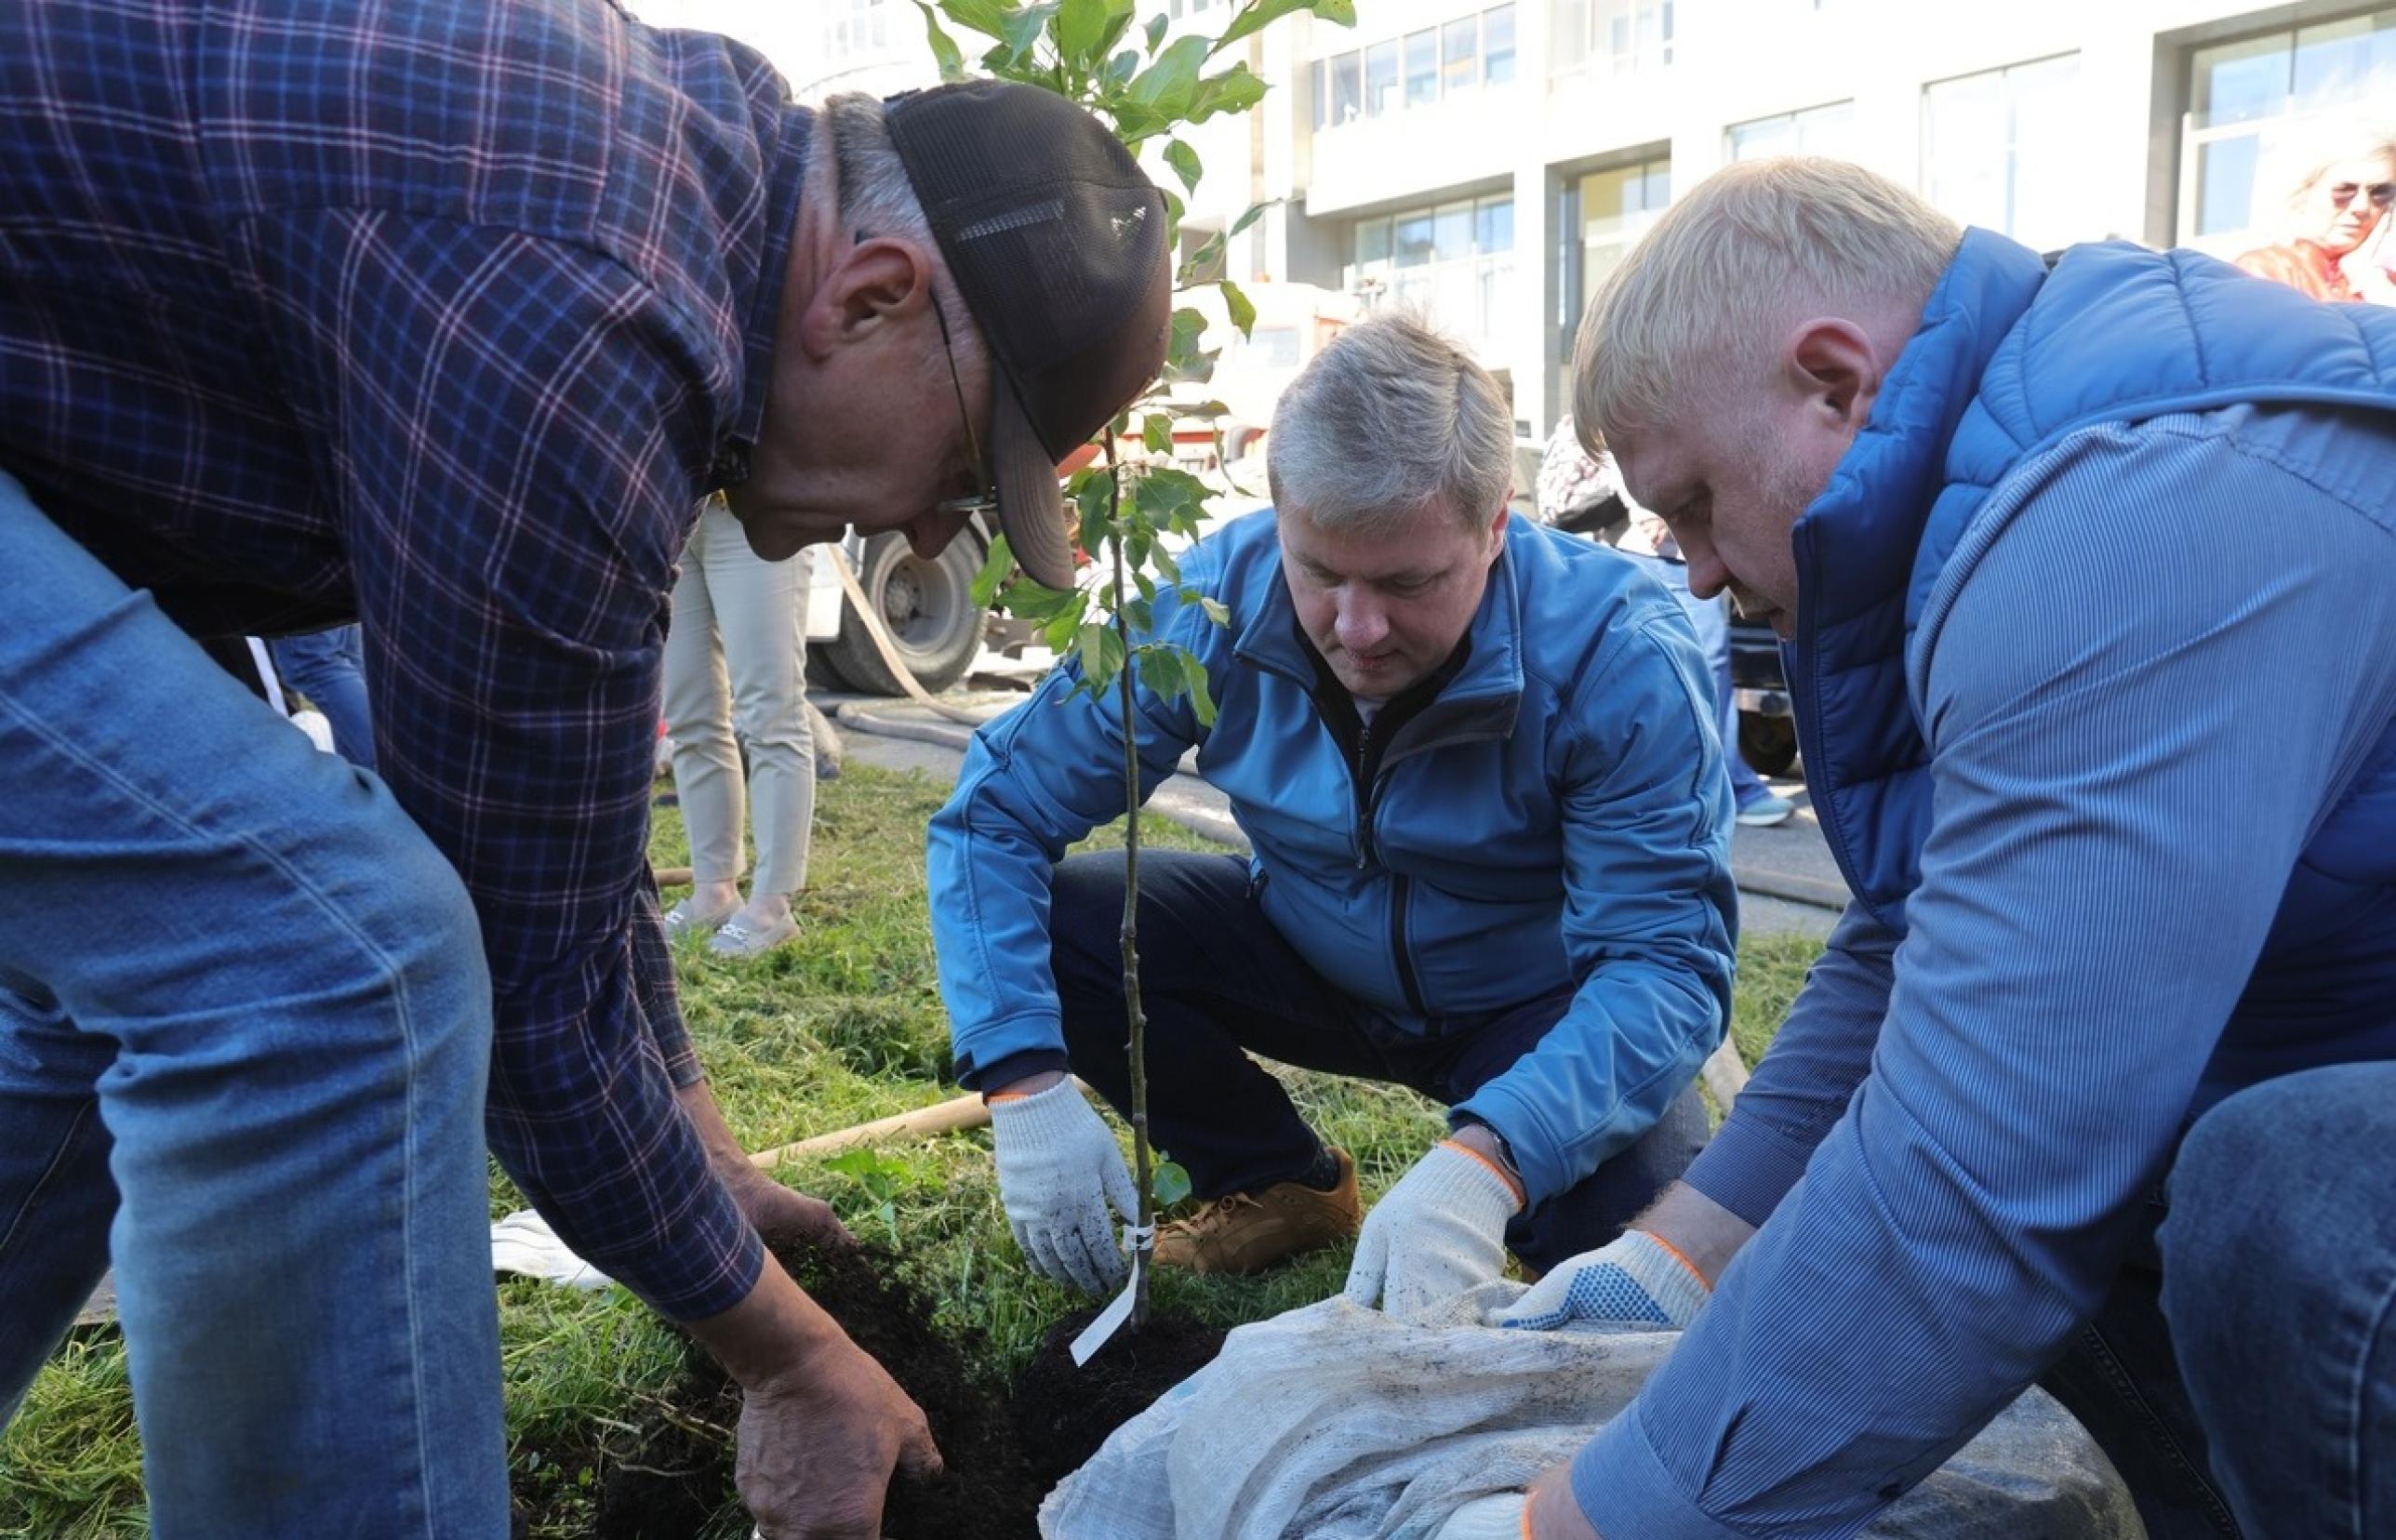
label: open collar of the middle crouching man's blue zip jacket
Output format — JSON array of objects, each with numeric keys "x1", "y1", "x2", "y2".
[{"x1": 1231, "y1": 511, "x2": 1536, "y2": 764}]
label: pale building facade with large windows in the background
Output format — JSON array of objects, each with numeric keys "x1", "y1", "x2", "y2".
[{"x1": 656, "y1": 0, "x2": 2396, "y2": 438}]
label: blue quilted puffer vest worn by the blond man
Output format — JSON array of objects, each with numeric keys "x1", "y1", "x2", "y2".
[{"x1": 1783, "y1": 230, "x2": 2396, "y2": 1099}]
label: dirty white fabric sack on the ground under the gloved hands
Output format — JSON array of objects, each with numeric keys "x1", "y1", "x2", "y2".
[{"x1": 1040, "y1": 1283, "x2": 2145, "y2": 1540}]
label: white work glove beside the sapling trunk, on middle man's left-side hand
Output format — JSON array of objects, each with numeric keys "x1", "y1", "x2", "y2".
[{"x1": 990, "y1": 1081, "x2": 1140, "y2": 1294}]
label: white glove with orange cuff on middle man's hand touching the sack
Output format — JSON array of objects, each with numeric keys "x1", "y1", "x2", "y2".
[{"x1": 1347, "y1": 1140, "x2": 1522, "y2": 1315}]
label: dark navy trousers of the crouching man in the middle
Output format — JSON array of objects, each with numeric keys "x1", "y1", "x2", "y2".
[{"x1": 1049, "y1": 850, "x2": 1706, "y2": 1272}]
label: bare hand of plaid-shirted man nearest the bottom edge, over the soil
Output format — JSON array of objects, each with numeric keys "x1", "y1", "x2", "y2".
[{"x1": 736, "y1": 1336, "x2": 941, "y2": 1540}]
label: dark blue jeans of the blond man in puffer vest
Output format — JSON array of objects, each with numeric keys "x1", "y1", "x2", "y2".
[{"x1": 2043, "y1": 1063, "x2": 2396, "y2": 1540}]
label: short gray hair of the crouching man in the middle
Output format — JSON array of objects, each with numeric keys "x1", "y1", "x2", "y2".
[{"x1": 1265, "y1": 313, "x2": 1514, "y2": 532}]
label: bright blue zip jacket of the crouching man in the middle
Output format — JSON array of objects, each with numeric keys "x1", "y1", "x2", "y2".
[{"x1": 929, "y1": 511, "x2": 1735, "y2": 1202}]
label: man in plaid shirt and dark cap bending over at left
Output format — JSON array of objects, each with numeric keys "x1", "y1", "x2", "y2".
[{"x1": 0, "y1": 0, "x2": 1169, "y2": 1535}]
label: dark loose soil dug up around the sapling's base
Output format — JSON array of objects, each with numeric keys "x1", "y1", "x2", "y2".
[{"x1": 522, "y1": 1245, "x2": 1224, "y2": 1540}]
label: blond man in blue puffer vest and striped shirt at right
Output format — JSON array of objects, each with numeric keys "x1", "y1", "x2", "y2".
[{"x1": 1517, "y1": 161, "x2": 2396, "y2": 1540}]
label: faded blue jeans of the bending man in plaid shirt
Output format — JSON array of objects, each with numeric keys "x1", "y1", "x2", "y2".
[{"x1": 0, "y1": 474, "x2": 508, "y2": 1540}]
